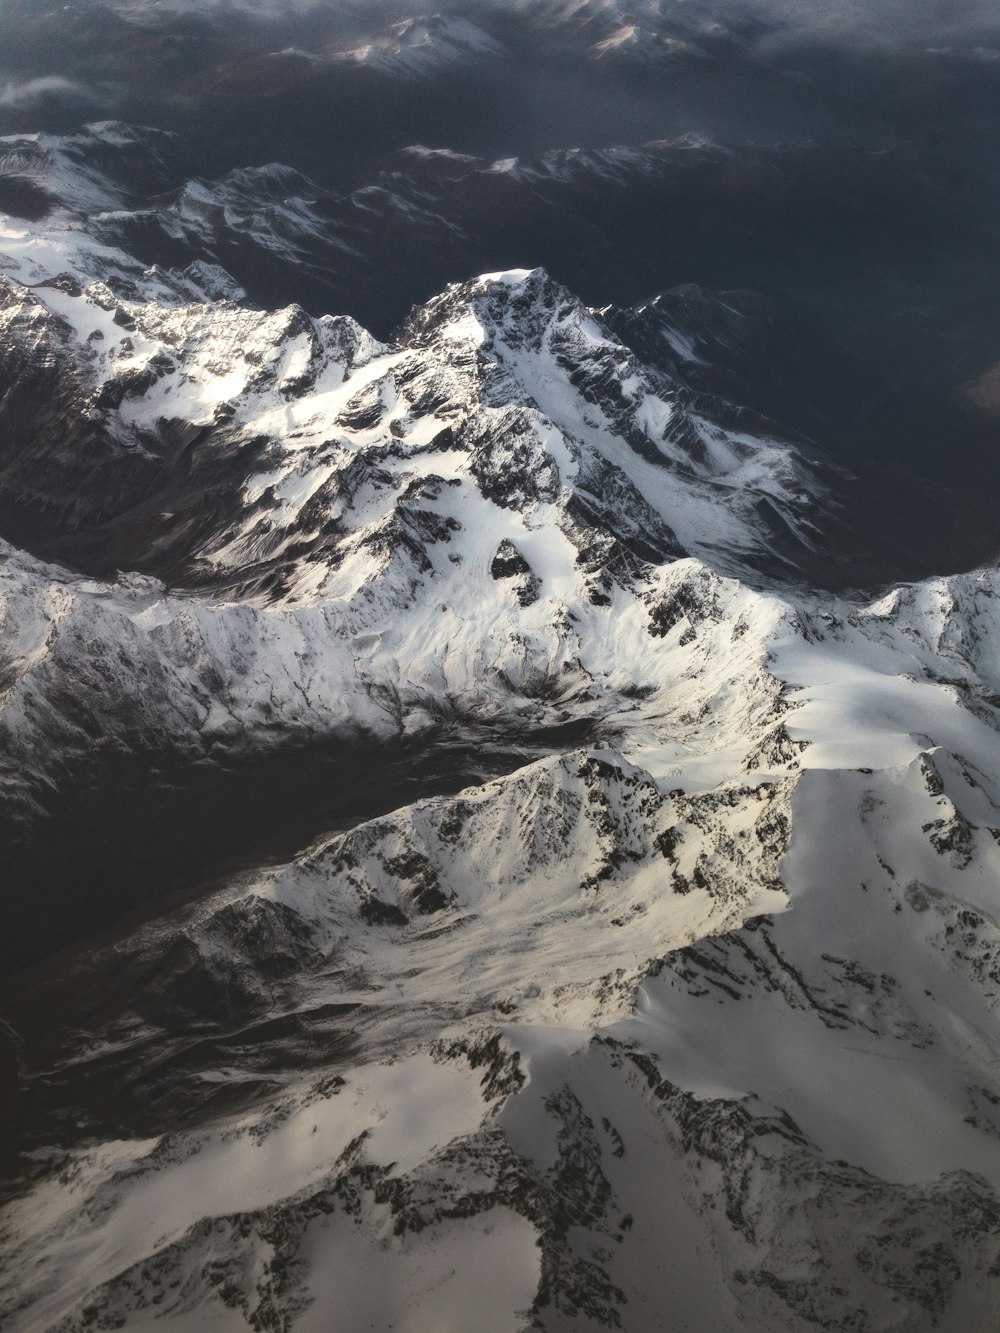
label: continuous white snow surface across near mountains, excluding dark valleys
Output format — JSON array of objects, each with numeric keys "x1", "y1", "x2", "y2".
[{"x1": 0, "y1": 231, "x2": 1000, "y2": 1333}]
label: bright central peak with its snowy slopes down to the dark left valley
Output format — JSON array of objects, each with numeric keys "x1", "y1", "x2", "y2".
[{"x1": 0, "y1": 239, "x2": 844, "y2": 946}]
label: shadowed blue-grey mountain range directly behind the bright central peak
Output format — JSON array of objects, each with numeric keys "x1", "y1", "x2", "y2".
[{"x1": 7, "y1": 123, "x2": 1000, "y2": 597}]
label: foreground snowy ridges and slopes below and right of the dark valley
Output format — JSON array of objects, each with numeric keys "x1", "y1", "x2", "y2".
[{"x1": 4, "y1": 551, "x2": 1000, "y2": 1330}]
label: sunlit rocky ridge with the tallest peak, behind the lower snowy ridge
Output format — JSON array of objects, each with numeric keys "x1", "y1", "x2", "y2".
[{"x1": 0, "y1": 258, "x2": 847, "y2": 601}]
